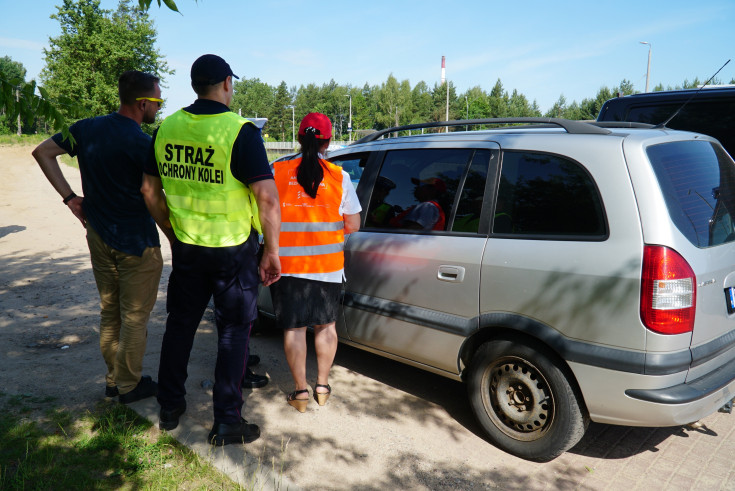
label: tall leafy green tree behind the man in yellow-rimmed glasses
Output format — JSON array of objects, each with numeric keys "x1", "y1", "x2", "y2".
[{"x1": 41, "y1": 0, "x2": 173, "y2": 122}]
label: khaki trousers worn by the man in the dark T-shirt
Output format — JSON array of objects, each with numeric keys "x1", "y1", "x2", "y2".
[{"x1": 87, "y1": 225, "x2": 163, "y2": 394}]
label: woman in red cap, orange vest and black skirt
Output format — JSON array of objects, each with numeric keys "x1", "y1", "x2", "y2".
[{"x1": 271, "y1": 113, "x2": 362, "y2": 413}]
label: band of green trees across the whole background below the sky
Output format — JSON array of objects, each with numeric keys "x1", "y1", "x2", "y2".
[{"x1": 0, "y1": 0, "x2": 735, "y2": 141}]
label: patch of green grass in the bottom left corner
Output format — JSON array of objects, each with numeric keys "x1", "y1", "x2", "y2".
[{"x1": 0, "y1": 394, "x2": 239, "y2": 490}]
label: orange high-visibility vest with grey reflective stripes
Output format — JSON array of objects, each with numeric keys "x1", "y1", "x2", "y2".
[{"x1": 273, "y1": 158, "x2": 345, "y2": 274}]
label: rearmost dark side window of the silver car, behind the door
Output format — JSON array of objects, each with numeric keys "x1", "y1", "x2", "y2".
[{"x1": 492, "y1": 152, "x2": 607, "y2": 240}]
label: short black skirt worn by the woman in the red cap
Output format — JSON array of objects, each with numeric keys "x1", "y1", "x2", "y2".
[{"x1": 270, "y1": 276, "x2": 342, "y2": 329}]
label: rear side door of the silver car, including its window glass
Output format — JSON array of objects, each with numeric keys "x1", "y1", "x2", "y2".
[{"x1": 343, "y1": 144, "x2": 498, "y2": 374}]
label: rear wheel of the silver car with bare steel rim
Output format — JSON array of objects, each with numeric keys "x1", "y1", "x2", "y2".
[{"x1": 468, "y1": 339, "x2": 589, "y2": 462}]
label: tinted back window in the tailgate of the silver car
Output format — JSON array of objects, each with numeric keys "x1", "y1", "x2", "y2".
[{"x1": 647, "y1": 141, "x2": 735, "y2": 247}]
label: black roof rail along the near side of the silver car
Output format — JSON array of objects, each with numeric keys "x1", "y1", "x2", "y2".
[{"x1": 355, "y1": 117, "x2": 610, "y2": 143}]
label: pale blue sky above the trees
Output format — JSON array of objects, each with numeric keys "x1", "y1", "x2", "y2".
[{"x1": 0, "y1": 0, "x2": 735, "y2": 115}]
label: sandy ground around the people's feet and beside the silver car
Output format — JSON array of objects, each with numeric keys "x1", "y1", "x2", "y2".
[{"x1": 5, "y1": 146, "x2": 732, "y2": 490}]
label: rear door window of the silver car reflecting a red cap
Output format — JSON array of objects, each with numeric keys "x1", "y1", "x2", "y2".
[{"x1": 365, "y1": 148, "x2": 474, "y2": 231}]
